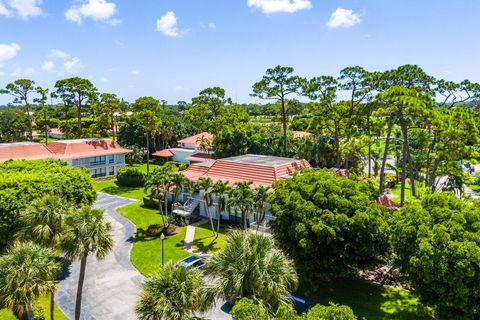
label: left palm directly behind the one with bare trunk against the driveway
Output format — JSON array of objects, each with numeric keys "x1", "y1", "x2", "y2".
[{"x1": 18, "y1": 195, "x2": 72, "y2": 320}]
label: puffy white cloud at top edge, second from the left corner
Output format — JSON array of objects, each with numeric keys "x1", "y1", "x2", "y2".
[{"x1": 65, "y1": 0, "x2": 121, "y2": 25}]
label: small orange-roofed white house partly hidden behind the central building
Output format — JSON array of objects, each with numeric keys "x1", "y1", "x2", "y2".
[{"x1": 152, "y1": 132, "x2": 214, "y2": 164}]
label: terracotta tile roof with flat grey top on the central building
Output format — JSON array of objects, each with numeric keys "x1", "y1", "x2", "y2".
[{"x1": 183, "y1": 155, "x2": 310, "y2": 186}]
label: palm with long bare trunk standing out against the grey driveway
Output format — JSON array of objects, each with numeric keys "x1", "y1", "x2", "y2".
[{"x1": 62, "y1": 207, "x2": 113, "y2": 320}]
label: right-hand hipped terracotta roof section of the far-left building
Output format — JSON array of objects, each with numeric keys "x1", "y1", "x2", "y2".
[{"x1": 47, "y1": 139, "x2": 131, "y2": 159}]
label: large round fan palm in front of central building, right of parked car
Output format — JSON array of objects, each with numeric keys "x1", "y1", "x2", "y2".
[{"x1": 206, "y1": 230, "x2": 298, "y2": 308}]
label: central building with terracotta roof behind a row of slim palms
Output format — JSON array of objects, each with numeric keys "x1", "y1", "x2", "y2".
[{"x1": 174, "y1": 154, "x2": 311, "y2": 227}]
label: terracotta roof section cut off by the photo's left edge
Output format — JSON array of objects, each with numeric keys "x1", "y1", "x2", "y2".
[{"x1": 0, "y1": 142, "x2": 52, "y2": 162}]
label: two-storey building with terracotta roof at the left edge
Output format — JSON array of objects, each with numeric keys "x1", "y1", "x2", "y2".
[{"x1": 0, "y1": 139, "x2": 131, "y2": 178}]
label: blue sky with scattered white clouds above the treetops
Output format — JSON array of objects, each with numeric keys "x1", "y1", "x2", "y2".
[{"x1": 0, "y1": 0, "x2": 480, "y2": 104}]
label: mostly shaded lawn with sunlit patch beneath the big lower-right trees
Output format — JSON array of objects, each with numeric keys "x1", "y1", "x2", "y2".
[{"x1": 297, "y1": 278, "x2": 431, "y2": 320}]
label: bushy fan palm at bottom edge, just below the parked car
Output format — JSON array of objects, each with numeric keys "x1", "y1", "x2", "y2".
[{"x1": 135, "y1": 262, "x2": 214, "y2": 320}]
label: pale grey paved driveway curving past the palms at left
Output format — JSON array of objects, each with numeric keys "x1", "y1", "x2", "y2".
[{"x1": 55, "y1": 193, "x2": 144, "y2": 320}]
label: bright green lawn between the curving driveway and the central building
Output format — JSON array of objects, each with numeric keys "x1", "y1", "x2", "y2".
[{"x1": 118, "y1": 202, "x2": 190, "y2": 275}]
